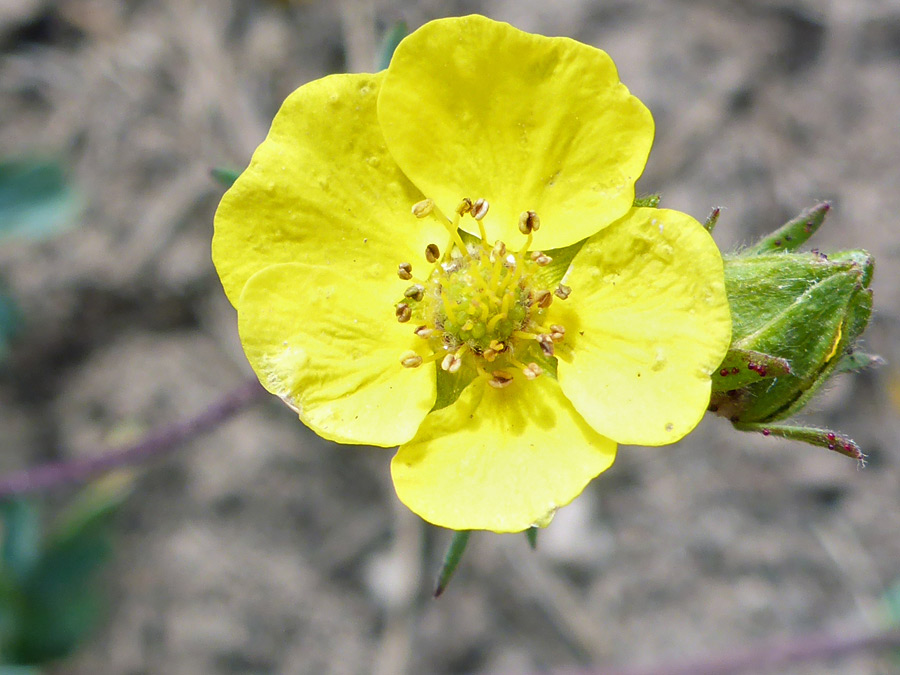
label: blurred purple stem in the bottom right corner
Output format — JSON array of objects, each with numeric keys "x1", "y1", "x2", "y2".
[{"x1": 588, "y1": 628, "x2": 900, "y2": 675}]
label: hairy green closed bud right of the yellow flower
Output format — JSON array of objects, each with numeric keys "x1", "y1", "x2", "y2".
[{"x1": 710, "y1": 204, "x2": 878, "y2": 459}]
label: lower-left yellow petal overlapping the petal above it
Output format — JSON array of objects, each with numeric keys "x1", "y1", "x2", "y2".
[{"x1": 238, "y1": 263, "x2": 435, "y2": 447}]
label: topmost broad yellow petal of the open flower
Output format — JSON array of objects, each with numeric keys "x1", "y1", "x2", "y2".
[{"x1": 378, "y1": 16, "x2": 653, "y2": 254}]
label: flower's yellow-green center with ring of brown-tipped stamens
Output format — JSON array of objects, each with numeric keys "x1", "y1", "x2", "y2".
[{"x1": 395, "y1": 199, "x2": 569, "y2": 388}]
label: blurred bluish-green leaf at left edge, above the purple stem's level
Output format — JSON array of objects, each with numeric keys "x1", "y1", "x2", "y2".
[{"x1": 0, "y1": 159, "x2": 83, "y2": 239}]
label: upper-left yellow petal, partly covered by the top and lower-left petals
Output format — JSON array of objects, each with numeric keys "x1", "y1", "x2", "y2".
[{"x1": 213, "y1": 74, "x2": 447, "y2": 304}]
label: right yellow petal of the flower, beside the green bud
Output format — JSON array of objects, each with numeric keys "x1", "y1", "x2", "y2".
[{"x1": 551, "y1": 208, "x2": 731, "y2": 445}]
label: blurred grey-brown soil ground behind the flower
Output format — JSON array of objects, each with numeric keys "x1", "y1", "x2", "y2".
[{"x1": 0, "y1": 0, "x2": 900, "y2": 675}]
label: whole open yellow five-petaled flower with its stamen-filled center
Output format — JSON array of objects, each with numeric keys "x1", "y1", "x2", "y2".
[{"x1": 213, "y1": 16, "x2": 731, "y2": 532}]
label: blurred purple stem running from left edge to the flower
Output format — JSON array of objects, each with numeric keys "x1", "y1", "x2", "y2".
[{"x1": 0, "y1": 377, "x2": 265, "y2": 498}]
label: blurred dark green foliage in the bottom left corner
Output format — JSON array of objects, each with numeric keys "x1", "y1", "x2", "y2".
[{"x1": 0, "y1": 474, "x2": 131, "y2": 675}]
